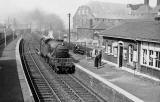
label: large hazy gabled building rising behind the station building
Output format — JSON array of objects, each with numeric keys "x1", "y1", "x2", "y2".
[{"x1": 73, "y1": 0, "x2": 160, "y2": 40}]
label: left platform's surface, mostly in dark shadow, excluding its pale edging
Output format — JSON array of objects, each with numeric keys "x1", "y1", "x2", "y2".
[{"x1": 0, "y1": 38, "x2": 23, "y2": 102}]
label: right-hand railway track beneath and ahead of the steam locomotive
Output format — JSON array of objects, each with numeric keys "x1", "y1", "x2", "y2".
[{"x1": 28, "y1": 36, "x2": 106, "y2": 102}]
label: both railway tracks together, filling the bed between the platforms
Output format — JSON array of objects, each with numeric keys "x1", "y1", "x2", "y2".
[{"x1": 22, "y1": 33, "x2": 106, "y2": 102}]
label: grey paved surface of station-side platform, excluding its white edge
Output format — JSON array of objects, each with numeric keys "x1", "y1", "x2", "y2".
[{"x1": 72, "y1": 53, "x2": 160, "y2": 102}]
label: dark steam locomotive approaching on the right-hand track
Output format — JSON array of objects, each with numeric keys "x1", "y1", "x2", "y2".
[{"x1": 40, "y1": 38, "x2": 75, "y2": 73}]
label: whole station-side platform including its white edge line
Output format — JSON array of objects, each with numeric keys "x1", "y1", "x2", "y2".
[{"x1": 72, "y1": 53, "x2": 160, "y2": 102}]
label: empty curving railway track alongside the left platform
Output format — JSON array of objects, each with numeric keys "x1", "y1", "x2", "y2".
[{"x1": 22, "y1": 39, "x2": 62, "y2": 102}]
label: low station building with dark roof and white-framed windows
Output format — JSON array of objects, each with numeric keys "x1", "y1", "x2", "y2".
[{"x1": 100, "y1": 20, "x2": 160, "y2": 78}]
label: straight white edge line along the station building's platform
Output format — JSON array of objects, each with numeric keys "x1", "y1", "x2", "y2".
[{"x1": 75, "y1": 63, "x2": 144, "y2": 102}]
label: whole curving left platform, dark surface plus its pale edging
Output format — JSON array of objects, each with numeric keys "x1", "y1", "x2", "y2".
[{"x1": 0, "y1": 37, "x2": 32, "y2": 102}]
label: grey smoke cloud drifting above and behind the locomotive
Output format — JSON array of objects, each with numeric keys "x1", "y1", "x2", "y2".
[{"x1": 16, "y1": 9, "x2": 65, "y2": 31}]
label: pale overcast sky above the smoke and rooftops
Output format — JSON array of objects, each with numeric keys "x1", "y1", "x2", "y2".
[{"x1": 0, "y1": 0, "x2": 156, "y2": 25}]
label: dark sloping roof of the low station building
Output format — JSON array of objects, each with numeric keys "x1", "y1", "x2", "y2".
[{"x1": 101, "y1": 21, "x2": 160, "y2": 42}]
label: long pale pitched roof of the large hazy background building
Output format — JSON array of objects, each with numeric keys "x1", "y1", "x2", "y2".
[{"x1": 87, "y1": 1, "x2": 128, "y2": 18}]
